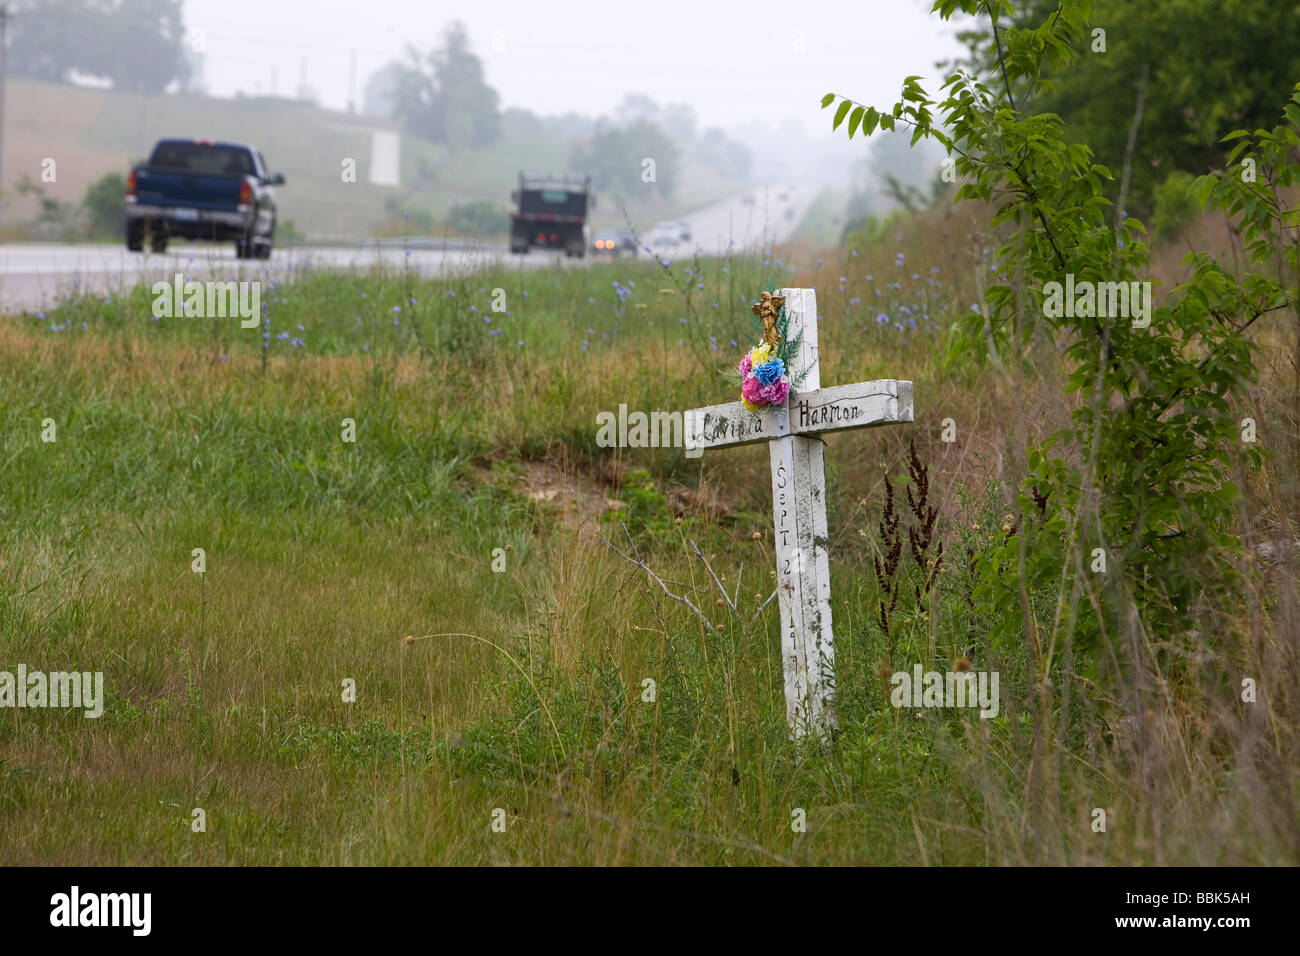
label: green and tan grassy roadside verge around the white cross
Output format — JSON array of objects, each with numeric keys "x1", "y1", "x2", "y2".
[{"x1": 0, "y1": 220, "x2": 1296, "y2": 864}]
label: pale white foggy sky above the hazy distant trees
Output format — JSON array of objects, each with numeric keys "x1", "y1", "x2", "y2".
[{"x1": 185, "y1": 0, "x2": 959, "y2": 138}]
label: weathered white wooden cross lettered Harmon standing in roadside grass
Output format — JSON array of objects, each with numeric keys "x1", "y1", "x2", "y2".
[{"x1": 683, "y1": 289, "x2": 911, "y2": 740}]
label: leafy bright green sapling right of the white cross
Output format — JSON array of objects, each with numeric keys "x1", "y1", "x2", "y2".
[{"x1": 822, "y1": 0, "x2": 1300, "y2": 685}]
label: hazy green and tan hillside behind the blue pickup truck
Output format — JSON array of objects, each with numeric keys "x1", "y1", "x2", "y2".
[{"x1": 4, "y1": 79, "x2": 733, "y2": 238}]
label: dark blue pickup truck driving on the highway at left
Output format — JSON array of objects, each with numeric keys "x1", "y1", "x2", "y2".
[{"x1": 126, "y1": 139, "x2": 285, "y2": 259}]
